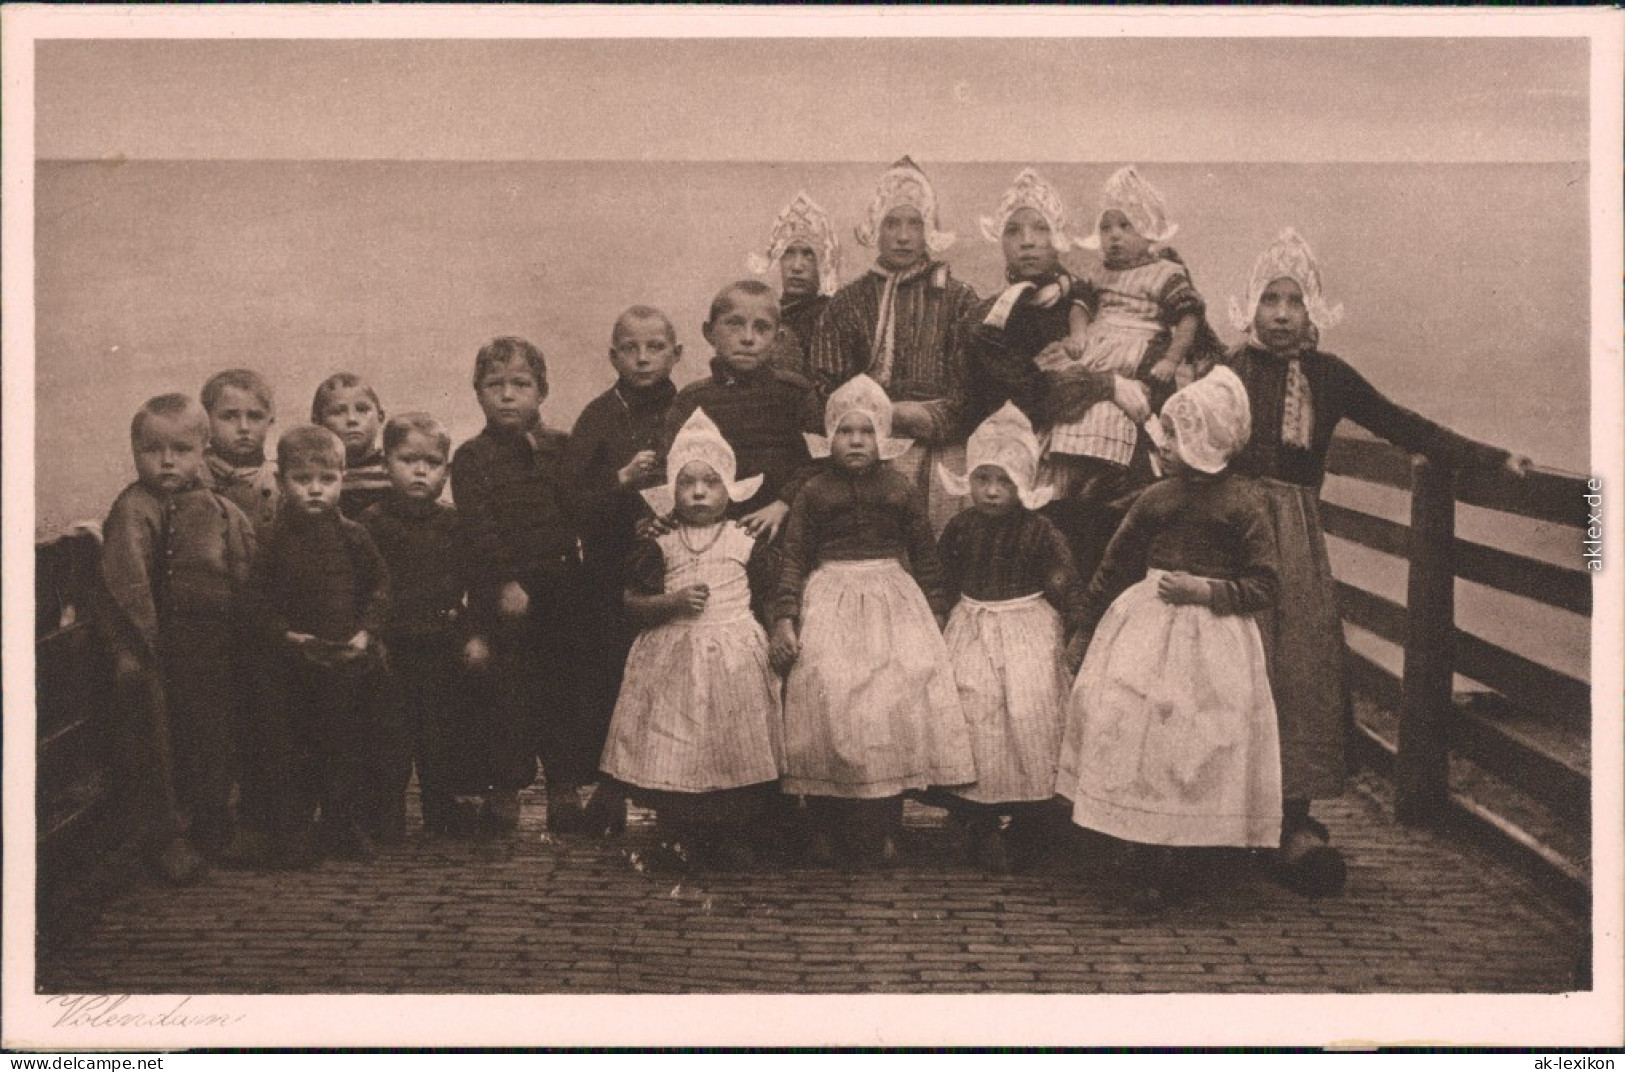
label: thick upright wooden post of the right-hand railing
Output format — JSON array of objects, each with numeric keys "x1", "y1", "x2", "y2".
[{"x1": 1394, "y1": 458, "x2": 1456, "y2": 825}]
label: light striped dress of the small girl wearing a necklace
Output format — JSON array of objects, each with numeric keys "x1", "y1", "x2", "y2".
[{"x1": 601, "y1": 521, "x2": 783, "y2": 793}]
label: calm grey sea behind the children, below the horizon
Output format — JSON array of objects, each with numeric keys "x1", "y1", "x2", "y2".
[{"x1": 36, "y1": 161, "x2": 1589, "y2": 534}]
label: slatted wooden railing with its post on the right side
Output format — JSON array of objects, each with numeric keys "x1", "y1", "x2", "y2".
[{"x1": 1321, "y1": 439, "x2": 1591, "y2": 897}]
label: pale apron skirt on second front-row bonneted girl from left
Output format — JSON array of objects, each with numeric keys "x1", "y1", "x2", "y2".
[{"x1": 783, "y1": 559, "x2": 977, "y2": 799}]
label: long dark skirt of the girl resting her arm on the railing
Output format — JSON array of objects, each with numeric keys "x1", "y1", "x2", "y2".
[{"x1": 1258, "y1": 479, "x2": 1352, "y2": 801}]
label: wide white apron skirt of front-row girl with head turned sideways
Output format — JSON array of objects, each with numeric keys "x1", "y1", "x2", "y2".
[{"x1": 1058, "y1": 570, "x2": 1281, "y2": 848}]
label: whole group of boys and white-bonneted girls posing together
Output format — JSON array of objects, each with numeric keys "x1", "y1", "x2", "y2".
[{"x1": 104, "y1": 162, "x2": 1521, "y2": 916}]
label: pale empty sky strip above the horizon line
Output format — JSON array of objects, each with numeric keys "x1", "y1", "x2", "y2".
[{"x1": 36, "y1": 30, "x2": 1589, "y2": 162}]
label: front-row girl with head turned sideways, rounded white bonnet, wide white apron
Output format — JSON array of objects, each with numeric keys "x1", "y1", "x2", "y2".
[{"x1": 1056, "y1": 367, "x2": 1281, "y2": 903}]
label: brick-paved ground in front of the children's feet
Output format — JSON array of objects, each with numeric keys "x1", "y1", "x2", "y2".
[{"x1": 37, "y1": 769, "x2": 1584, "y2": 994}]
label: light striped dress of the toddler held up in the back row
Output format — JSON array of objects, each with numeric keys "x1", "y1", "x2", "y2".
[{"x1": 1050, "y1": 255, "x2": 1203, "y2": 466}]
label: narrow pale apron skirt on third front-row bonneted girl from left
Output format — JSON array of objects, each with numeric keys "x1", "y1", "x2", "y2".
[{"x1": 943, "y1": 593, "x2": 1068, "y2": 804}]
